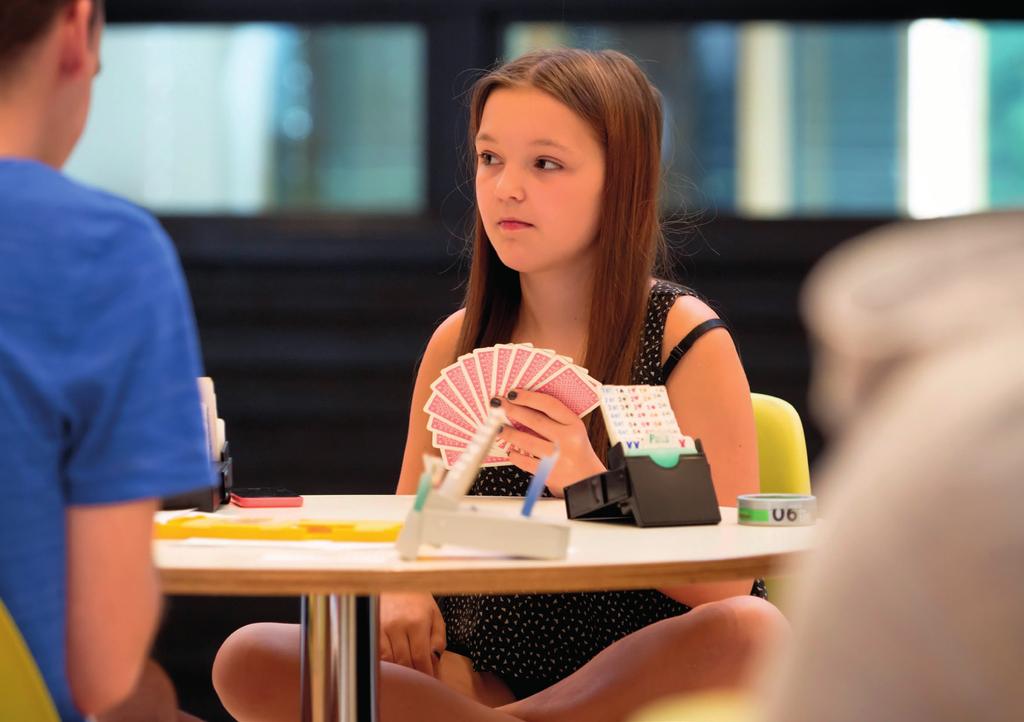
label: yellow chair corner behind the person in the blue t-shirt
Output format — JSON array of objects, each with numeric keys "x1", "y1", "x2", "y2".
[{"x1": 0, "y1": 600, "x2": 60, "y2": 722}]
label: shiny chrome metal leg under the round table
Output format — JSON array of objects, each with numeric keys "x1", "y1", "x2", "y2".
[{"x1": 302, "y1": 594, "x2": 380, "y2": 722}]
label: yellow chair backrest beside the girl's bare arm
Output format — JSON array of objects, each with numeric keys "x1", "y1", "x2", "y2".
[{"x1": 751, "y1": 393, "x2": 811, "y2": 494}]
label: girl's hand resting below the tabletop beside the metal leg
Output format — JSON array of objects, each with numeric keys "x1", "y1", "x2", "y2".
[{"x1": 380, "y1": 592, "x2": 445, "y2": 677}]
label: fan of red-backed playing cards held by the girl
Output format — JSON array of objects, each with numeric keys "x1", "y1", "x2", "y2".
[{"x1": 423, "y1": 343, "x2": 601, "y2": 469}]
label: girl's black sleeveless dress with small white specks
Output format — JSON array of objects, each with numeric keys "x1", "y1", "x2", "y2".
[{"x1": 437, "y1": 281, "x2": 765, "y2": 698}]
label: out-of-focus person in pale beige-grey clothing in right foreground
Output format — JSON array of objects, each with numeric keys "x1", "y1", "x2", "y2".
[{"x1": 762, "y1": 212, "x2": 1024, "y2": 722}]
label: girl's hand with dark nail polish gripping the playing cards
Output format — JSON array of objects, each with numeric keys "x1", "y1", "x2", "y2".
[{"x1": 499, "y1": 389, "x2": 605, "y2": 497}]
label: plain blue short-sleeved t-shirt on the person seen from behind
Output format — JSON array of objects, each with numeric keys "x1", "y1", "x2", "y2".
[{"x1": 0, "y1": 159, "x2": 213, "y2": 720}]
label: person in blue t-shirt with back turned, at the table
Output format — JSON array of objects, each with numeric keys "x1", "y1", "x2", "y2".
[{"x1": 0, "y1": 0, "x2": 212, "y2": 722}]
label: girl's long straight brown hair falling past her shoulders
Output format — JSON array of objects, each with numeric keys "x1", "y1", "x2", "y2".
[{"x1": 457, "y1": 49, "x2": 665, "y2": 458}]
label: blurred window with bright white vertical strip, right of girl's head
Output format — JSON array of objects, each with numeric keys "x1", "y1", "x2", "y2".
[{"x1": 505, "y1": 20, "x2": 1024, "y2": 217}]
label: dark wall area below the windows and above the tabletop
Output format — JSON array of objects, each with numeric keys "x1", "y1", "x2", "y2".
[{"x1": 164, "y1": 217, "x2": 884, "y2": 494}]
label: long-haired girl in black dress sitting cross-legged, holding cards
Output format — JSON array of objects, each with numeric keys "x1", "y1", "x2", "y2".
[{"x1": 214, "y1": 50, "x2": 782, "y2": 722}]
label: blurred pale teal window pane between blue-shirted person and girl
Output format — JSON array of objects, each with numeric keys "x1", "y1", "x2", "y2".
[{"x1": 68, "y1": 24, "x2": 427, "y2": 214}]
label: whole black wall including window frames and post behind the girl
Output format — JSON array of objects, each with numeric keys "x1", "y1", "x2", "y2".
[{"x1": 97, "y1": 0, "x2": 1015, "y2": 720}]
